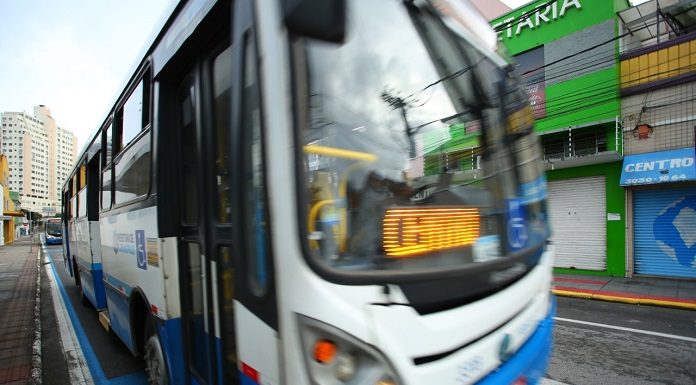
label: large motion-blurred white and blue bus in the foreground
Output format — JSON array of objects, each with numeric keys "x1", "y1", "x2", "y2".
[{"x1": 63, "y1": 0, "x2": 554, "y2": 385}]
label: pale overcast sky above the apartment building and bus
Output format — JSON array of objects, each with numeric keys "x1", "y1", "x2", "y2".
[{"x1": 0, "y1": 0, "x2": 528, "y2": 148}]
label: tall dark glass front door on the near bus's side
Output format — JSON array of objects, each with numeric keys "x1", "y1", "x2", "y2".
[{"x1": 167, "y1": 8, "x2": 238, "y2": 385}]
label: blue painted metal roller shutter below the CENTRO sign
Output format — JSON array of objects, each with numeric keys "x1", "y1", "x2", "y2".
[{"x1": 633, "y1": 187, "x2": 696, "y2": 278}]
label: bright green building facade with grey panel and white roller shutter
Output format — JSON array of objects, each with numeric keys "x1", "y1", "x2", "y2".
[{"x1": 491, "y1": 0, "x2": 629, "y2": 276}]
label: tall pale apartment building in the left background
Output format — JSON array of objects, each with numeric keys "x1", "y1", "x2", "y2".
[{"x1": 0, "y1": 105, "x2": 77, "y2": 215}]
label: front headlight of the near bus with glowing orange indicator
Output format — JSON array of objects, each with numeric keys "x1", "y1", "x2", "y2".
[{"x1": 298, "y1": 315, "x2": 399, "y2": 385}]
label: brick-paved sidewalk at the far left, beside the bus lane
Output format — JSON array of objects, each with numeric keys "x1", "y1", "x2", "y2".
[{"x1": 0, "y1": 238, "x2": 41, "y2": 385}]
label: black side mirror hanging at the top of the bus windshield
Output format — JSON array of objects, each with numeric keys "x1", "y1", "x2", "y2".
[{"x1": 280, "y1": 0, "x2": 346, "y2": 43}]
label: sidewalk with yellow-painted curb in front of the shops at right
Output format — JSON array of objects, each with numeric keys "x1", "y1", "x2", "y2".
[{"x1": 553, "y1": 274, "x2": 696, "y2": 310}]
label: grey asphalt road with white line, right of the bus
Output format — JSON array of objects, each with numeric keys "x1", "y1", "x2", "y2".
[{"x1": 547, "y1": 297, "x2": 696, "y2": 385}]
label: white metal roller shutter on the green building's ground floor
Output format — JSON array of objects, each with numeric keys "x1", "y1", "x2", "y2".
[{"x1": 548, "y1": 176, "x2": 607, "y2": 270}]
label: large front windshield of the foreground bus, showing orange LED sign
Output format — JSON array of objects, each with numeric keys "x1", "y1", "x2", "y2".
[{"x1": 295, "y1": 1, "x2": 548, "y2": 275}]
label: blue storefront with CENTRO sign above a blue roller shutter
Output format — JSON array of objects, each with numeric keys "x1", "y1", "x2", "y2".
[{"x1": 621, "y1": 148, "x2": 696, "y2": 278}]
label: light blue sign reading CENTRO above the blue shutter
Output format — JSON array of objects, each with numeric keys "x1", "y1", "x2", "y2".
[{"x1": 621, "y1": 148, "x2": 696, "y2": 186}]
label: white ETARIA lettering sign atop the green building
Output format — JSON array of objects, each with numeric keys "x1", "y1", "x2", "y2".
[{"x1": 493, "y1": 0, "x2": 582, "y2": 40}]
